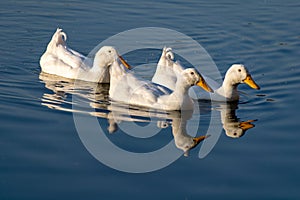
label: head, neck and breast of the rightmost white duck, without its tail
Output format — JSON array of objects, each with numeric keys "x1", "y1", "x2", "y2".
[{"x1": 190, "y1": 64, "x2": 260, "y2": 102}]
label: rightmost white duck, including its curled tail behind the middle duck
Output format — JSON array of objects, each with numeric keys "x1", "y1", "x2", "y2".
[{"x1": 152, "y1": 47, "x2": 260, "y2": 101}]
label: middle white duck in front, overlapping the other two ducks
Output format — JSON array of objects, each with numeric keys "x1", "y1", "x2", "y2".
[{"x1": 109, "y1": 60, "x2": 212, "y2": 110}]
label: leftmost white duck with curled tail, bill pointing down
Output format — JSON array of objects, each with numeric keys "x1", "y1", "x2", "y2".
[{"x1": 40, "y1": 28, "x2": 130, "y2": 83}]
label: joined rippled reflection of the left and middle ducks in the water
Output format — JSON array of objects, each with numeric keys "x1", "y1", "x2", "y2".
[{"x1": 40, "y1": 72, "x2": 207, "y2": 156}]
